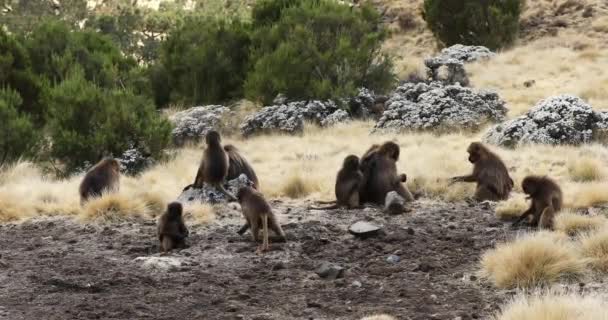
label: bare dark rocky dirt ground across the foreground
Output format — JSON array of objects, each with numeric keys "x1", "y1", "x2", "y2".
[{"x1": 0, "y1": 200, "x2": 517, "y2": 320}]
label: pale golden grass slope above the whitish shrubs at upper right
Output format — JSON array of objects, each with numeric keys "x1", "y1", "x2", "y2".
[{"x1": 467, "y1": 30, "x2": 608, "y2": 117}]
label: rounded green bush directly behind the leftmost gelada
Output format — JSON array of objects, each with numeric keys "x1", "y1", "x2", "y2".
[{"x1": 48, "y1": 69, "x2": 171, "y2": 171}]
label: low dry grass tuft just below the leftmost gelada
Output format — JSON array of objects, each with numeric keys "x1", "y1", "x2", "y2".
[{"x1": 79, "y1": 193, "x2": 150, "y2": 223}]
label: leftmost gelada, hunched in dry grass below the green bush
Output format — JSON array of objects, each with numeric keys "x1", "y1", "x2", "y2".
[{"x1": 78, "y1": 157, "x2": 120, "y2": 204}]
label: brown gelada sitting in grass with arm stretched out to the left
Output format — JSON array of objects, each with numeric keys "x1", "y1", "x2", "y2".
[{"x1": 450, "y1": 142, "x2": 513, "y2": 201}]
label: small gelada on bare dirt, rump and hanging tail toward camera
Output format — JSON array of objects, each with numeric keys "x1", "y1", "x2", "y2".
[{"x1": 237, "y1": 187, "x2": 285, "y2": 251}]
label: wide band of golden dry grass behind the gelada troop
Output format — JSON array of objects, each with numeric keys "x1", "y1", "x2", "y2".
[{"x1": 0, "y1": 122, "x2": 608, "y2": 221}]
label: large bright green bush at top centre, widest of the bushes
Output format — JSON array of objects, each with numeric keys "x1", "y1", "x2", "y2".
[{"x1": 245, "y1": 0, "x2": 395, "y2": 103}]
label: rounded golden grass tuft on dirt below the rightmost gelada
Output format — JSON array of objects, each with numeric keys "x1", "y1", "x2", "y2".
[{"x1": 481, "y1": 232, "x2": 586, "y2": 288}]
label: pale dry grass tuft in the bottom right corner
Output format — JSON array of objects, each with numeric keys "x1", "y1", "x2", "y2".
[{"x1": 492, "y1": 292, "x2": 608, "y2": 320}]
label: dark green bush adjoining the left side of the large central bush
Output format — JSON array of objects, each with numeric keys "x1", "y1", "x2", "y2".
[{"x1": 159, "y1": 17, "x2": 250, "y2": 104}]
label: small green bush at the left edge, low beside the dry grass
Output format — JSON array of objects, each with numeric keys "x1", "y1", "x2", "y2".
[{"x1": 0, "y1": 89, "x2": 38, "y2": 166}]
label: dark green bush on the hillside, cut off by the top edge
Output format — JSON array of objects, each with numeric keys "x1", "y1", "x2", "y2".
[{"x1": 423, "y1": 0, "x2": 523, "y2": 50}]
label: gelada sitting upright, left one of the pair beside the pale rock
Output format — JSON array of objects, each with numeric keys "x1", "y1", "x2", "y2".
[{"x1": 192, "y1": 131, "x2": 236, "y2": 201}]
